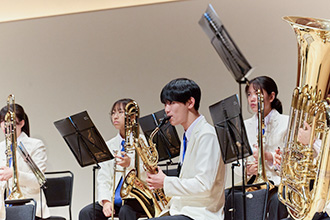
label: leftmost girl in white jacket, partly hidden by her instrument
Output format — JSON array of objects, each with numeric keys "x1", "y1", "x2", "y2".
[{"x1": 0, "y1": 104, "x2": 50, "y2": 219}]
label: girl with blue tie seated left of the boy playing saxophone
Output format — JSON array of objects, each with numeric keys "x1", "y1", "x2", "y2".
[{"x1": 79, "y1": 99, "x2": 146, "y2": 220}]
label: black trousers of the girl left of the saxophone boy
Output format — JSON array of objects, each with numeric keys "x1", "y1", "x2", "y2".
[{"x1": 79, "y1": 199, "x2": 144, "y2": 220}]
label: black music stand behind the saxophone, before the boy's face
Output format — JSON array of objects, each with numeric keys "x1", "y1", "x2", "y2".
[{"x1": 139, "y1": 110, "x2": 181, "y2": 174}]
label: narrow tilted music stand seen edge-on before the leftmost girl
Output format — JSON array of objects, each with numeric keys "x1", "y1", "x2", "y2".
[{"x1": 17, "y1": 142, "x2": 47, "y2": 188}]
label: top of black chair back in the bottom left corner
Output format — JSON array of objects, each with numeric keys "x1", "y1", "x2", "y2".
[{"x1": 5, "y1": 199, "x2": 36, "y2": 220}]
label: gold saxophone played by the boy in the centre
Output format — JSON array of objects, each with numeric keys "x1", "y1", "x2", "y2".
[{"x1": 120, "y1": 101, "x2": 169, "y2": 218}]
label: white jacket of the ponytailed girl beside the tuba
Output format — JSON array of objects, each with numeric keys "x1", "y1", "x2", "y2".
[{"x1": 241, "y1": 109, "x2": 289, "y2": 186}]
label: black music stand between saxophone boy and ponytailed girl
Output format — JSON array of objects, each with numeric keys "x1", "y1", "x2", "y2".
[{"x1": 209, "y1": 95, "x2": 252, "y2": 219}]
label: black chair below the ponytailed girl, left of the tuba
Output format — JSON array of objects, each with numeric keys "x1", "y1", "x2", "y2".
[{"x1": 225, "y1": 183, "x2": 269, "y2": 220}]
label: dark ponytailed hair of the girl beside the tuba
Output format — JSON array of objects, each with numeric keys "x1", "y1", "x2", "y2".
[{"x1": 245, "y1": 76, "x2": 283, "y2": 114}]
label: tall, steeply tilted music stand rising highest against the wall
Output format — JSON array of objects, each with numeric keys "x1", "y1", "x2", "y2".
[{"x1": 198, "y1": 4, "x2": 253, "y2": 105}]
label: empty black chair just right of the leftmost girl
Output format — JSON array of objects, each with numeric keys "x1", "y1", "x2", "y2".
[{"x1": 44, "y1": 171, "x2": 73, "y2": 220}]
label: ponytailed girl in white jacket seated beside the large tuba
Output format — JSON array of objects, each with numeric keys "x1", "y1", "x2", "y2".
[{"x1": 235, "y1": 76, "x2": 289, "y2": 220}]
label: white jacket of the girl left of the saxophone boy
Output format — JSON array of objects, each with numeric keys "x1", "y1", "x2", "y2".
[{"x1": 97, "y1": 134, "x2": 147, "y2": 205}]
